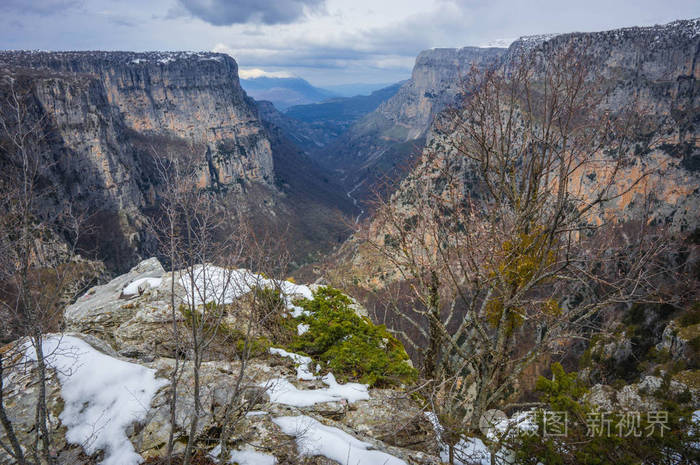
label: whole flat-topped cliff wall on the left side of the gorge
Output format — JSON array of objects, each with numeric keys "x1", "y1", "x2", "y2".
[{"x1": 0, "y1": 52, "x2": 350, "y2": 271}]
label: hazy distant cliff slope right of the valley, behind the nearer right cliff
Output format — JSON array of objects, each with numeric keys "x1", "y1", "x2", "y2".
[{"x1": 321, "y1": 47, "x2": 506, "y2": 199}]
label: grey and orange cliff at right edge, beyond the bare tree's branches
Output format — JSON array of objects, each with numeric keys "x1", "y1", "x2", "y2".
[{"x1": 537, "y1": 19, "x2": 700, "y2": 230}]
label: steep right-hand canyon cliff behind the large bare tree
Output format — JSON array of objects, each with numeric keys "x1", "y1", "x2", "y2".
[{"x1": 314, "y1": 20, "x2": 700, "y2": 436}]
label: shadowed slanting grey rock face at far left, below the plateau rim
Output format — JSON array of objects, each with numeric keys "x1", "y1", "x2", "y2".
[{"x1": 27, "y1": 74, "x2": 144, "y2": 209}]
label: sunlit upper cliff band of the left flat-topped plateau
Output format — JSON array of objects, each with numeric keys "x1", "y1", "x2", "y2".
[{"x1": 0, "y1": 52, "x2": 273, "y2": 184}]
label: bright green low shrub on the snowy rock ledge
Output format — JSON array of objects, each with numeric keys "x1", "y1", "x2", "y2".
[{"x1": 289, "y1": 287, "x2": 417, "y2": 386}]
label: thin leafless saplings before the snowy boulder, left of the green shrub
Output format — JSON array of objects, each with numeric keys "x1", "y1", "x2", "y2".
[{"x1": 152, "y1": 147, "x2": 288, "y2": 464}]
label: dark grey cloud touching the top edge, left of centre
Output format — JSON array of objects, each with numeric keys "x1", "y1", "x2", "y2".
[{"x1": 179, "y1": 0, "x2": 325, "y2": 26}]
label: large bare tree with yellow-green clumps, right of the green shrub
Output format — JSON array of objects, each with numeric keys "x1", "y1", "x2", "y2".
[{"x1": 364, "y1": 47, "x2": 668, "y2": 462}]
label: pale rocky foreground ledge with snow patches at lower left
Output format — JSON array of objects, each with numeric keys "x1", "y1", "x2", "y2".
[{"x1": 0, "y1": 259, "x2": 440, "y2": 465}]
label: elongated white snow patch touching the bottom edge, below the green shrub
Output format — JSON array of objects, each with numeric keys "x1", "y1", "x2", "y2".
[{"x1": 272, "y1": 415, "x2": 406, "y2": 465}]
